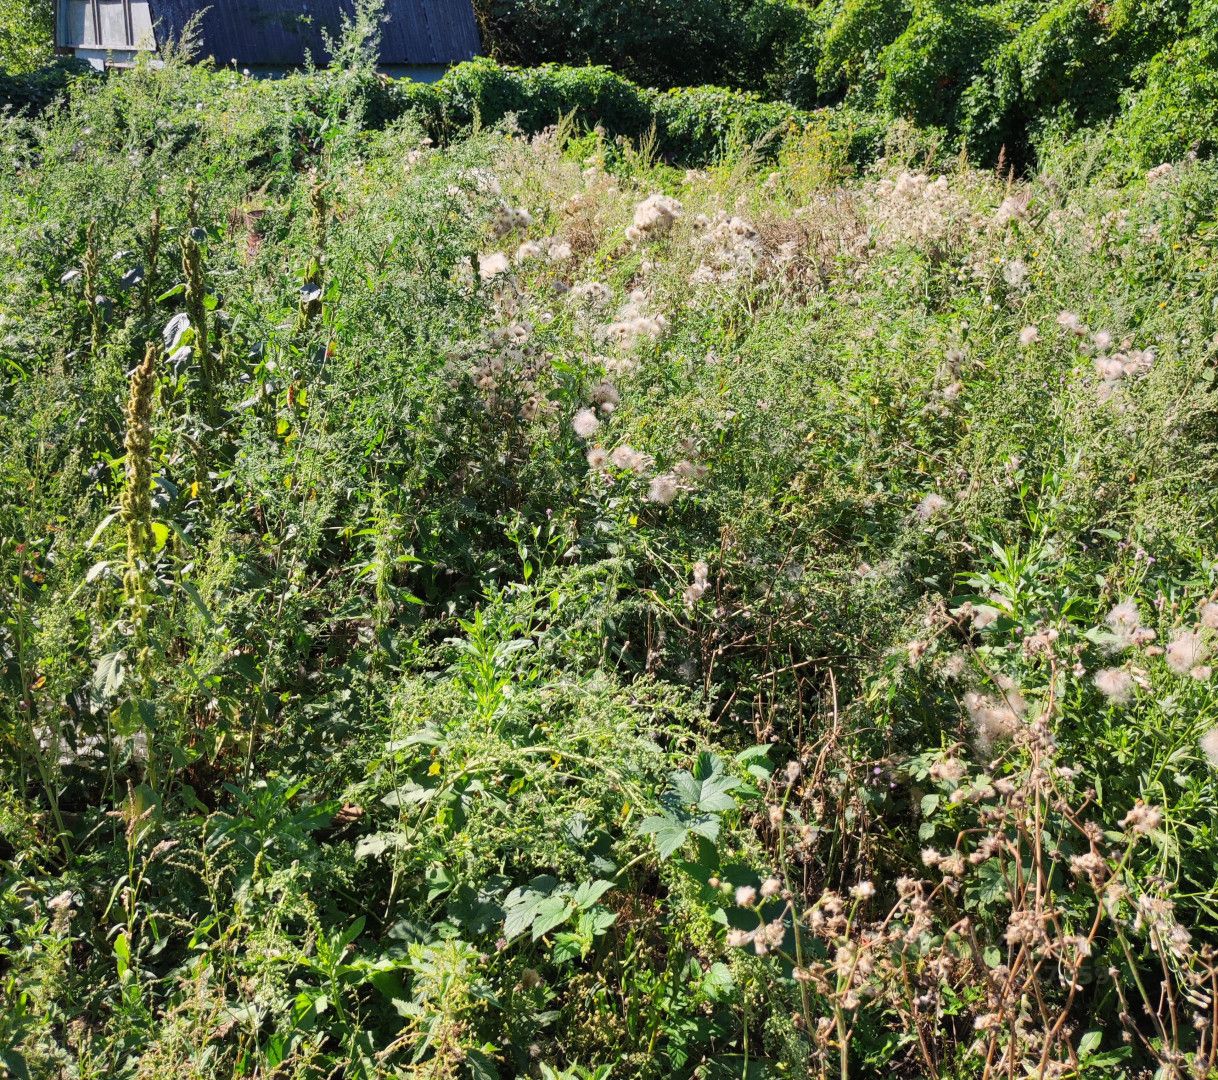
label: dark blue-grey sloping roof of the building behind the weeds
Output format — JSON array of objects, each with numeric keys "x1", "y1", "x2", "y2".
[{"x1": 150, "y1": 0, "x2": 479, "y2": 66}]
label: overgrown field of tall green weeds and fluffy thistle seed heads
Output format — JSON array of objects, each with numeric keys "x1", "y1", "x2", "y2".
[{"x1": 0, "y1": 46, "x2": 1218, "y2": 1080}]
